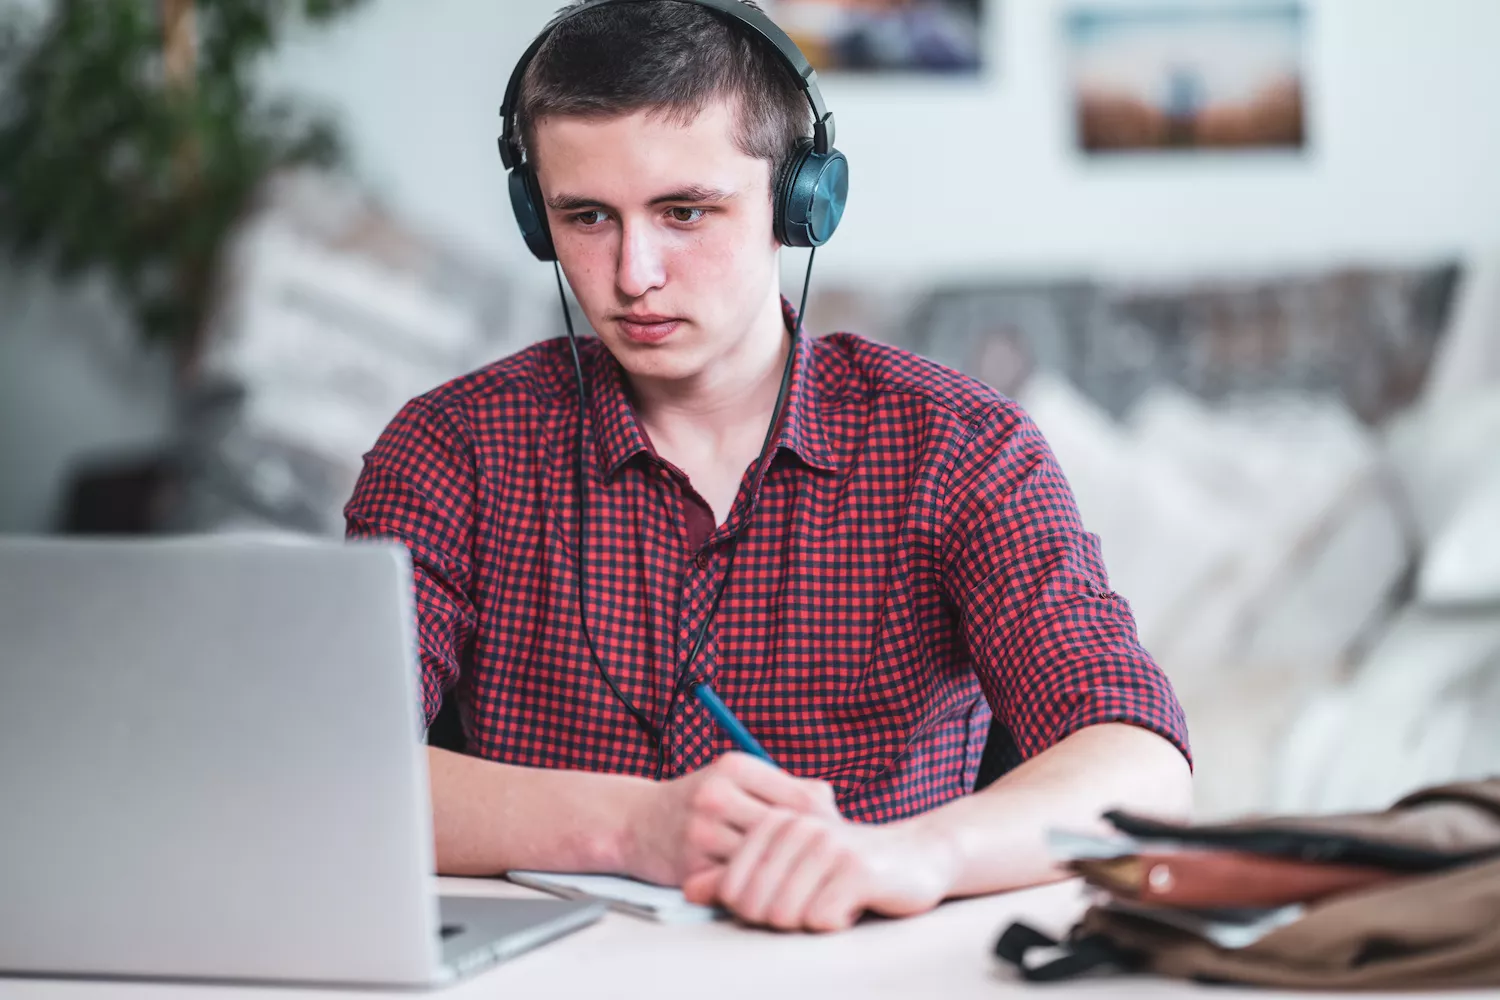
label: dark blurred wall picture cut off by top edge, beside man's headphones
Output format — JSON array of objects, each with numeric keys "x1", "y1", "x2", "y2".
[{"x1": 762, "y1": 0, "x2": 995, "y2": 75}]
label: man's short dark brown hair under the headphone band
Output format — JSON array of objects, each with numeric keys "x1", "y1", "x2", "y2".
[{"x1": 515, "y1": 0, "x2": 813, "y2": 194}]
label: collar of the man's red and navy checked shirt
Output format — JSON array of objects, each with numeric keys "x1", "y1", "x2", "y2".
[{"x1": 591, "y1": 298, "x2": 839, "y2": 480}]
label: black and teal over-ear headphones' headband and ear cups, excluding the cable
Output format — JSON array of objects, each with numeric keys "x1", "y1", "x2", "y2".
[{"x1": 500, "y1": 0, "x2": 849, "y2": 261}]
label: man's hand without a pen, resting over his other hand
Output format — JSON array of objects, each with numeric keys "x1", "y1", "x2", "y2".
[{"x1": 683, "y1": 810, "x2": 957, "y2": 931}]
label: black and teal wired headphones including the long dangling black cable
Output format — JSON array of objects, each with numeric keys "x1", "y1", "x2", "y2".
[{"x1": 500, "y1": 0, "x2": 849, "y2": 780}]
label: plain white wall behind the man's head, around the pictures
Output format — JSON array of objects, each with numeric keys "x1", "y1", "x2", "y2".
[{"x1": 272, "y1": 0, "x2": 1500, "y2": 276}]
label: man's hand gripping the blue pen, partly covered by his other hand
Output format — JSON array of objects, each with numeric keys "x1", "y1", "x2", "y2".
[{"x1": 626, "y1": 753, "x2": 839, "y2": 886}]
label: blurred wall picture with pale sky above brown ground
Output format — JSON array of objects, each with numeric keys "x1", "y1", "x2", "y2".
[{"x1": 1064, "y1": 0, "x2": 1307, "y2": 156}]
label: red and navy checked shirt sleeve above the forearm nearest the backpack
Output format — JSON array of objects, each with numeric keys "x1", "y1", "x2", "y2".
[{"x1": 939, "y1": 403, "x2": 1193, "y2": 763}]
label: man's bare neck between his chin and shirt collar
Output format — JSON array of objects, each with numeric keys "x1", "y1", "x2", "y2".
[{"x1": 632, "y1": 297, "x2": 791, "y2": 453}]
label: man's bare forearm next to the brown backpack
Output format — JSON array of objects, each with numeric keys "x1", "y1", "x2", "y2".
[{"x1": 905, "y1": 724, "x2": 1193, "y2": 897}]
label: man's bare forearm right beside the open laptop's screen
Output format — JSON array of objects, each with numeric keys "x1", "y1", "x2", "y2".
[{"x1": 428, "y1": 747, "x2": 653, "y2": 876}]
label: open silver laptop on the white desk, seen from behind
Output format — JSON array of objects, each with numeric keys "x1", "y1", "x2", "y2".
[{"x1": 0, "y1": 538, "x2": 602, "y2": 987}]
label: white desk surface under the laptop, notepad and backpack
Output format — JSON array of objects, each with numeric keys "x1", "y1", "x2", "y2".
[{"x1": 0, "y1": 879, "x2": 1494, "y2": 1000}]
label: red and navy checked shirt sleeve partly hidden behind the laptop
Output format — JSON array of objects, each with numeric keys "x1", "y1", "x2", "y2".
[{"x1": 344, "y1": 399, "x2": 476, "y2": 726}]
